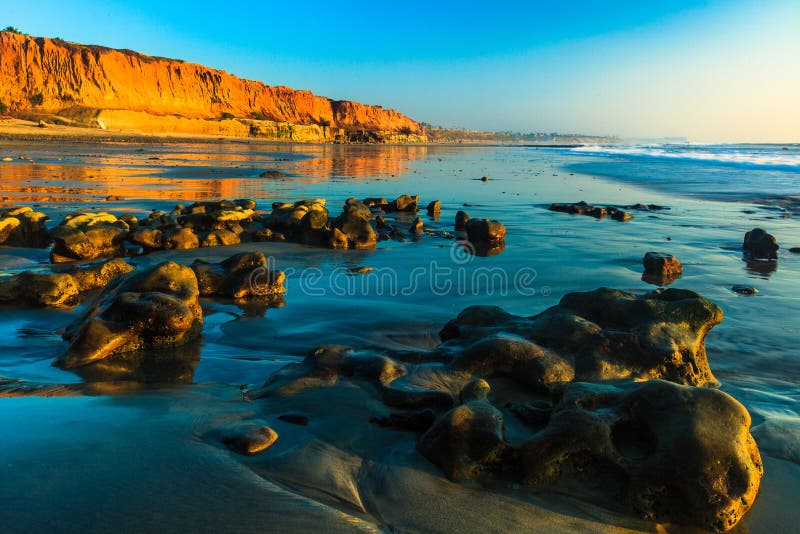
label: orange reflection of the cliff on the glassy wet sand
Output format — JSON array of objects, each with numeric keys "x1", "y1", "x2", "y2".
[{"x1": 0, "y1": 143, "x2": 428, "y2": 205}]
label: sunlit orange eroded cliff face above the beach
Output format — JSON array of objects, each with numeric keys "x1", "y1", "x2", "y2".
[{"x1": 0, "y1": 32, "x2": 424, "y2": 140}]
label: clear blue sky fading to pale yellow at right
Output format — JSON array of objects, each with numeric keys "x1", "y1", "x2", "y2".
[{"x1": 6, "y1": 0, "x2": 800, "y2": 143}]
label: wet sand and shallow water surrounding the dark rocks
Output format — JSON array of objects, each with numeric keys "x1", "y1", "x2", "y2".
[{"x1": 0, "y1": 139, "x2": 800, "y2": 532}]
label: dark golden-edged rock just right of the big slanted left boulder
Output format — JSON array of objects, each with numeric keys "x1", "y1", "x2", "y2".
[{"x1": 191, "y1": 252, "x2": 286, "y2": 299}]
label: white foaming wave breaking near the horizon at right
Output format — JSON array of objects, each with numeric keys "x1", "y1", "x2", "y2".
[{"x1": 571, "y1": 145, "x2": 800, "y2": 167}]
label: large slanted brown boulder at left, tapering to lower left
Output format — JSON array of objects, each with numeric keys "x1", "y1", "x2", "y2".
[{"x1": 56, "y1": 262, "x2": 203, "y2": 368}]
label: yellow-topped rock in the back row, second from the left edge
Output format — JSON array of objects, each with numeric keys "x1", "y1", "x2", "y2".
[{"x1": 50, "y1": 212, "x2": 129, "y2": 263}]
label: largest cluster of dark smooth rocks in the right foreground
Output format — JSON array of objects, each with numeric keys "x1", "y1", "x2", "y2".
[{"x1": 249, "y1": 289, "x2": 763, "y2": 531}]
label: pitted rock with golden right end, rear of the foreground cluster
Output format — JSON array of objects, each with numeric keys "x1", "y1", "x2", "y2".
[{"x1": 440, "y1": 288, "x2": 722, "y2": 386}]
